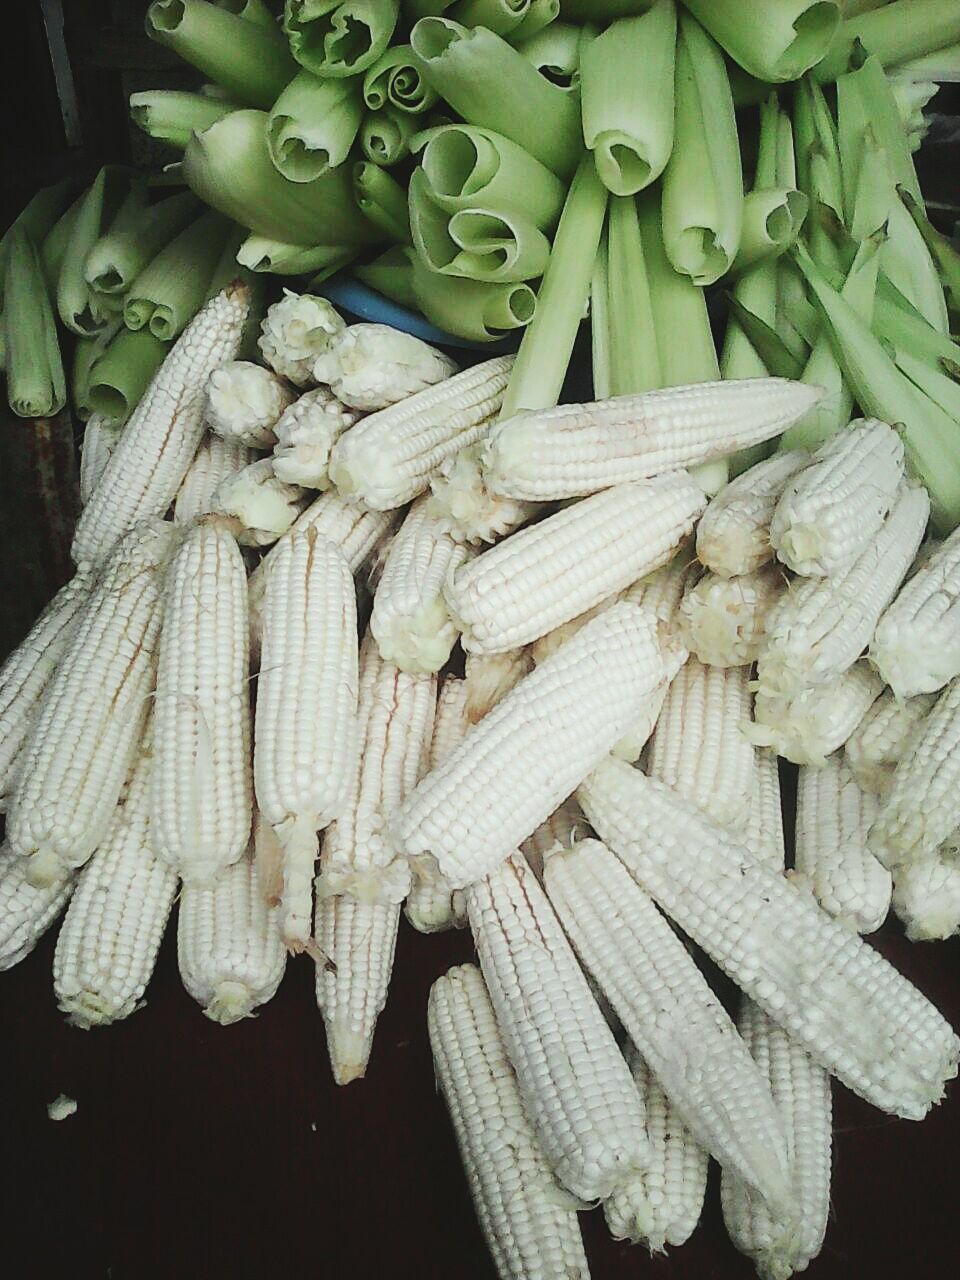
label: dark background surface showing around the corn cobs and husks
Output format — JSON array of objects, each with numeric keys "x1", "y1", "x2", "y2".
[{"x1": 0, "y1": 0, "x2": 960, "y2": 1280}]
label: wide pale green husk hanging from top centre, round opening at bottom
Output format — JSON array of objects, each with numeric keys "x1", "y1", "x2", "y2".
[{"x1": 581, "y1": 0, "x2": 677, "y2": 196}]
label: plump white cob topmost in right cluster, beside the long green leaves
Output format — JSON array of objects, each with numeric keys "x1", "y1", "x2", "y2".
[{"x1": 771, "y1": 417, "x2": 904, "y2": 577}]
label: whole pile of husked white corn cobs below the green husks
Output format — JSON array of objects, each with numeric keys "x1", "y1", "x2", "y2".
[{"x1": 0, "y1": 283, "x2": 960, "y2": 1280}]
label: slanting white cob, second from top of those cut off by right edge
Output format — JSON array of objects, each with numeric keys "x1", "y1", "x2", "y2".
[{"x1": 869, "y1": 678, "x2": 960, "y2": 869}]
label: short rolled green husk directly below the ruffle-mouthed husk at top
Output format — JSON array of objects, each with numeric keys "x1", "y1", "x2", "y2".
[{"x1": 266, "y1": 72, "x2": 364, "y2": 182}]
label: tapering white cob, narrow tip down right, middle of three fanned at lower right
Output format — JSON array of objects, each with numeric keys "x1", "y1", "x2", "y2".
[{"x1": 544, "y1": 840, "x2": 790, "y2": 1211}]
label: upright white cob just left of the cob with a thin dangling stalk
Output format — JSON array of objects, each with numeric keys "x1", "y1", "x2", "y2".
[{"x1": 150, "y1": 516, "x2": 253, "y2": 883}]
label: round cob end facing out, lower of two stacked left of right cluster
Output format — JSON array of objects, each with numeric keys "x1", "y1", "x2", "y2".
[{"x1": 680, "y1": 564, "x2": 785, "y2": 667}]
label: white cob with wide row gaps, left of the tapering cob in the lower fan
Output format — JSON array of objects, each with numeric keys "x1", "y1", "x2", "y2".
[{"x1": 466, "y1": 854, "x2": 649, "y2": 1201}]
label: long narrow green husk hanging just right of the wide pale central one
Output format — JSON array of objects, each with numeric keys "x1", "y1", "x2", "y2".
[{"x1": 662, "y1": 12, "x2": 744, "y2": 284}]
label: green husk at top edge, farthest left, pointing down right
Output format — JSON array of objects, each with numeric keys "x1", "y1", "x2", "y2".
[{"x1": 147, "y1": 0, "x2": 297, "y2": 108}]
